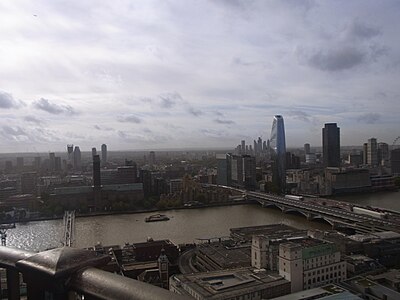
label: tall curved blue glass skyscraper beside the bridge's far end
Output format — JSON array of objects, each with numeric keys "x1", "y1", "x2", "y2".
[{"x1": 269, "y1": 115, "x2": 286, "y2": 193}]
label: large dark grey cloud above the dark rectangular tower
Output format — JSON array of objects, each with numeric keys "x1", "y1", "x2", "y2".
[{"x1": 306, "y1": 47, "x2": 366, "y2": 71}]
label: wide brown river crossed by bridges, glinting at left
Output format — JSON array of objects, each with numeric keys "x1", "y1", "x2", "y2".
[{"x1": 7, "y1": 192, "x2": 400, "y2": 251}]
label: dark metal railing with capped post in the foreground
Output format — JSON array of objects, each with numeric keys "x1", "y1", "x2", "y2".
[{"x1": 0, "y1": 246, "x2": 192, "y2": 300}]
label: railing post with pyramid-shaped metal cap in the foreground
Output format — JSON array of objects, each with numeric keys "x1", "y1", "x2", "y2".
[{"x1": 15, "y1": 247, "x2": 110, "y2": 300}]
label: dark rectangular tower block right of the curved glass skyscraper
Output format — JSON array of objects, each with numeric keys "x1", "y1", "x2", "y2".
[{"x1": 322, "y1": 123, "x2": 340, "y2": 167}]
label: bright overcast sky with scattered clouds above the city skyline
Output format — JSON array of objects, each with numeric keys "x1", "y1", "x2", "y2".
[{"x1": 0, "y1": 0, "x2": 400, "y2": 152}]
